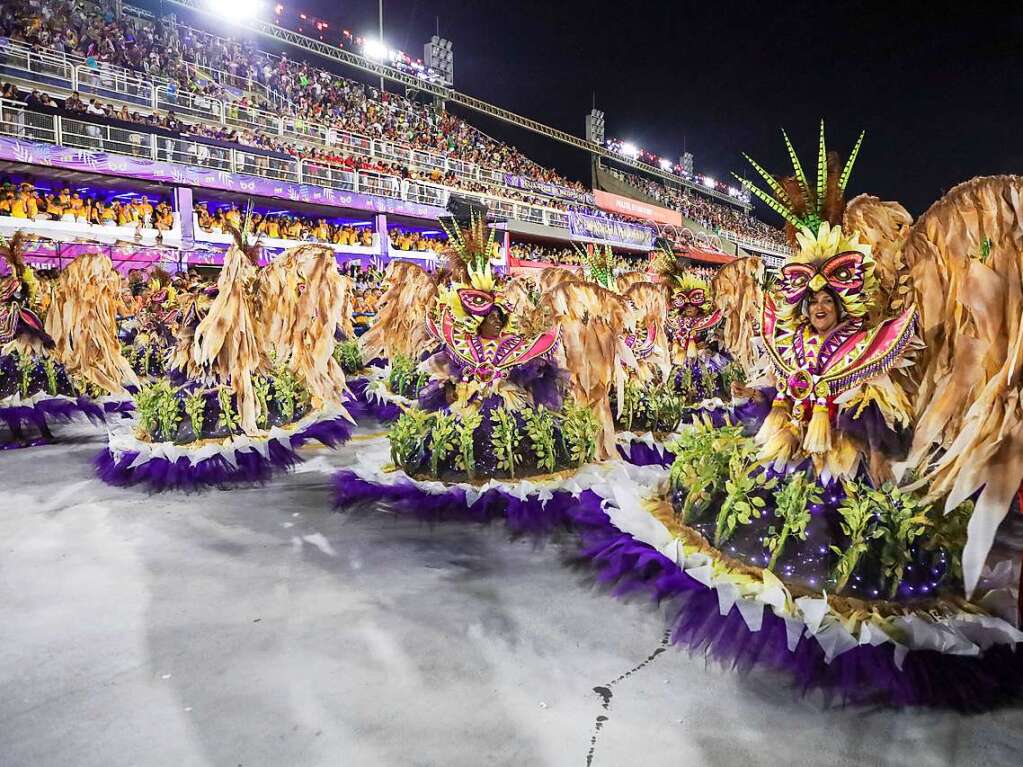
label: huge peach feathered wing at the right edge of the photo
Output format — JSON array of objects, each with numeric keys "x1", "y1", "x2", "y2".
[{"x1": 902, "y1": 176, "x2": 1023, "y2": 595}]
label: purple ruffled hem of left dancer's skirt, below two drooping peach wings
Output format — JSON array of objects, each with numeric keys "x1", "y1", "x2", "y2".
[{"x1": 93, "y1": 418, "x2": 352, "y2": 493}]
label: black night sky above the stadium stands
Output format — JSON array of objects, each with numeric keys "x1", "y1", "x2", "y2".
[{"x1": 203, "y1": 0, "x2": 1023, "y2": 220}]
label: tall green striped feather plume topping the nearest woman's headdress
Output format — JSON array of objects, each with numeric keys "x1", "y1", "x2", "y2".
[{"x1": 731, "y1": 120, "x2": 866, "y2": 238}]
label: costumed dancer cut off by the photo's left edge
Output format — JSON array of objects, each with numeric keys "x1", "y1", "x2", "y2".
[{"x1": 0, "y1": 232, "x2": 103, "y2": 448}]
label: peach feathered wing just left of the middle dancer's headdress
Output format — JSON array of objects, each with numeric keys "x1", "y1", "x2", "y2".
[{"x1": 359, "y1": 261, "x2": 437, "y2": 360}]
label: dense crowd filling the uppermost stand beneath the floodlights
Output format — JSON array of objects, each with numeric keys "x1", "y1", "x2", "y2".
[{"x1": 0, "y1": 0, "x2": 584, "y2": 198}]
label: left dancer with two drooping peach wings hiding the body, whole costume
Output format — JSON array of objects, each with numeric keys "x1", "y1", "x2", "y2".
[{"x1": 97, "y1": 224, "x2": 352, "y2": 490}]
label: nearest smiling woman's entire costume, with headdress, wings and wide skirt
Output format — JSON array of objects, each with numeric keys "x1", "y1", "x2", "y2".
[{"x1": 589, "y1": 124, "x2": 1023, "y2": 710}]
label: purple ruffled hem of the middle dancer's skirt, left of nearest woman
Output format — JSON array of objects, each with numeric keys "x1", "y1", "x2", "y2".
[{"x1": 333, "y1": 469, "x2": 601, "y2": 535}]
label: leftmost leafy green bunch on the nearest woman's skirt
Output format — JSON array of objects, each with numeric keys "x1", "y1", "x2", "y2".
[{"x1": 668, "y1": 418, "x2": 745, "y2": 523}]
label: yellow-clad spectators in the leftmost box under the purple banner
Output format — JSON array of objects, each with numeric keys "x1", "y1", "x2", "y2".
[{"x1": 0, "y1": 179, "x2": 174, "y2": 231}]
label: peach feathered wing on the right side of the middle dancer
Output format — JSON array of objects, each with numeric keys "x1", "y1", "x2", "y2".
[{"x1": 541, "y1": 281, "x2": 634, "y2": 460}]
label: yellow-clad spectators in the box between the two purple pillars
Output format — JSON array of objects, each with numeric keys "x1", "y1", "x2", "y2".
[{"x1": 194, "y1": 202, "x2": 373, "y2": 247}]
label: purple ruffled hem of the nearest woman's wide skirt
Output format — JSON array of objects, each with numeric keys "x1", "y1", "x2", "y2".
[{"x1": 572, "y1": 506, "x2": 1023, "y2": 712}]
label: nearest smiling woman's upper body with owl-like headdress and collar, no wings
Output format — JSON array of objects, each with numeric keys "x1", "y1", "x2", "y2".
[{"x1": 732, "y1": 127, "x2": 916, "y2": 485}]
